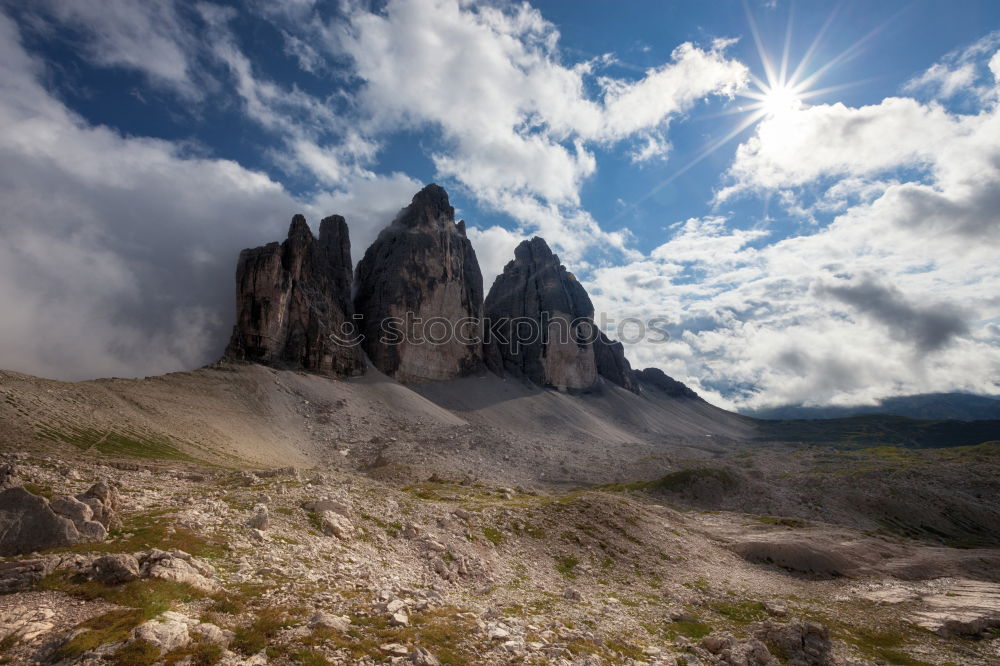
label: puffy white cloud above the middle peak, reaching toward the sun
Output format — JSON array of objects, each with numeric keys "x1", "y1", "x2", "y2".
[{"x1": 328, "y1": 0, "x2": 747, "y2": 259}]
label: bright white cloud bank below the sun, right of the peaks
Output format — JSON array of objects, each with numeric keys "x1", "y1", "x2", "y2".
[{"x1": 588, "y1": 40, "x2": 1000, "y2": 407}]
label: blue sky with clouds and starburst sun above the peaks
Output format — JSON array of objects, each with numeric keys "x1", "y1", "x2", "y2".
[{"x1": 0, "y1": 0, "x2": 1000, "y2": 409}]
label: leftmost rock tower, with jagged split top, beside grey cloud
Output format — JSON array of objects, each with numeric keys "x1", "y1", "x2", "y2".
[{"x1": 225, "y1": 215, "x2": 365, "y2": 376}]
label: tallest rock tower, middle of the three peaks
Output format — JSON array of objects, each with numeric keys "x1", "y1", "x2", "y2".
[{"x1": 354, "y1": 185, "x2": 483, "y2": 382}]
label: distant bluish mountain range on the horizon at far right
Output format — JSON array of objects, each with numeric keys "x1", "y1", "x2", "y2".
[{"x1": 742, "y1": 393, "x2": 1000, "y2": 421}]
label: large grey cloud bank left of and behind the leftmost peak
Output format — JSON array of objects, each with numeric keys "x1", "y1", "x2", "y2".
[{"x1": 0, "y1": 14, "x2": 419, "y2": 379}]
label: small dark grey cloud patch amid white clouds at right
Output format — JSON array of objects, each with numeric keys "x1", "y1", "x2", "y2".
[{"x1": 817, "y1": 277, "x2": 969, "y2": 351}]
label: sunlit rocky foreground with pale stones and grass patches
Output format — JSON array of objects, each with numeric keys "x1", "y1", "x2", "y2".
[{"x1": 0, "y1": 451, "x2": 1000, "y2": 665}]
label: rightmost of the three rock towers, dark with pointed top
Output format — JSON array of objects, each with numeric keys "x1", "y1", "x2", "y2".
[{"x1": 485, "y1": 237, "x2": 638, "y2": 391}]
